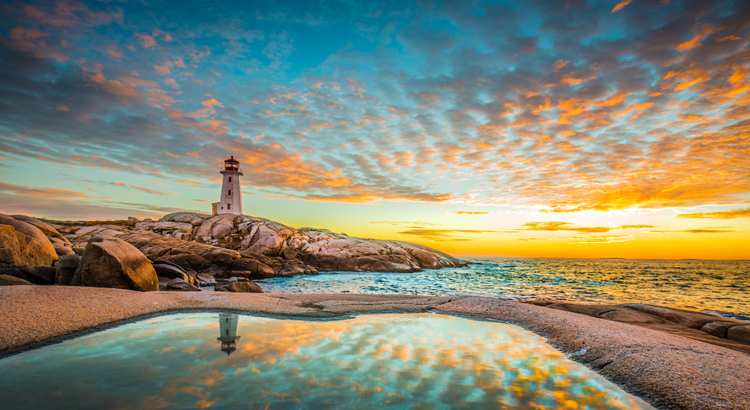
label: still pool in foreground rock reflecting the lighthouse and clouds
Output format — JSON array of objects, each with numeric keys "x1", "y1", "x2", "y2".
[{"x1": 0, "y1": 313, "x2": 652, "y2": 410}]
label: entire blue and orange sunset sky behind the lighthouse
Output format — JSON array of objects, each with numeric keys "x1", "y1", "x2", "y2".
[{"x1": 0, "y1": 0, "x2": 750, "y2": 259}]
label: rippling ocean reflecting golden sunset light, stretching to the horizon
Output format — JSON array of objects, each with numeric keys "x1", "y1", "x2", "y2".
[{"x1": 258, "y1": 258, "x2": 750, "y2": 320}]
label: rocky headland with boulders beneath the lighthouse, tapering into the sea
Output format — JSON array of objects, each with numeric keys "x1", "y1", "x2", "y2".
[{"x1": 0, "y1": 212, "x2": 468, "y2": 291}]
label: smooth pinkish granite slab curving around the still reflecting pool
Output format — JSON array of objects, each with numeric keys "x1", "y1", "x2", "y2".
[{"x1": 0, "y1": 286, "x2": 750, "y2": 409}]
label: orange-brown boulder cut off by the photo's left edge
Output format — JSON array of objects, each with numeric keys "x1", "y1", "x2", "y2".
[{"x1": 0, "y1": 223, "x2": 57, "y2": 266}]
